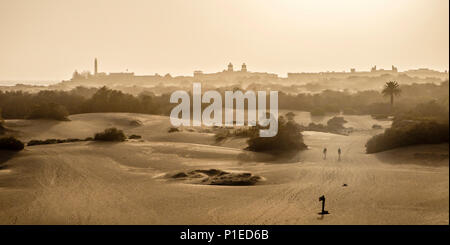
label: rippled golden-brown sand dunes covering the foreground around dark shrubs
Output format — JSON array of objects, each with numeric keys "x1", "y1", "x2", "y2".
[{"x1": 0, "y1": 114, "x2": 449, "y2": 224}]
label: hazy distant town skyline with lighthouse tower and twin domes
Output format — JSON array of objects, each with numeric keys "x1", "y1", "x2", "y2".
[{"x1": 63, "y1": 58, "x2": 448, "y2": 87}]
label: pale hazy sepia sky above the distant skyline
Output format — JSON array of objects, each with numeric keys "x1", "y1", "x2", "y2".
[{"x1": 0, "y1": 0, "x2": 449, "y2": 80}]
